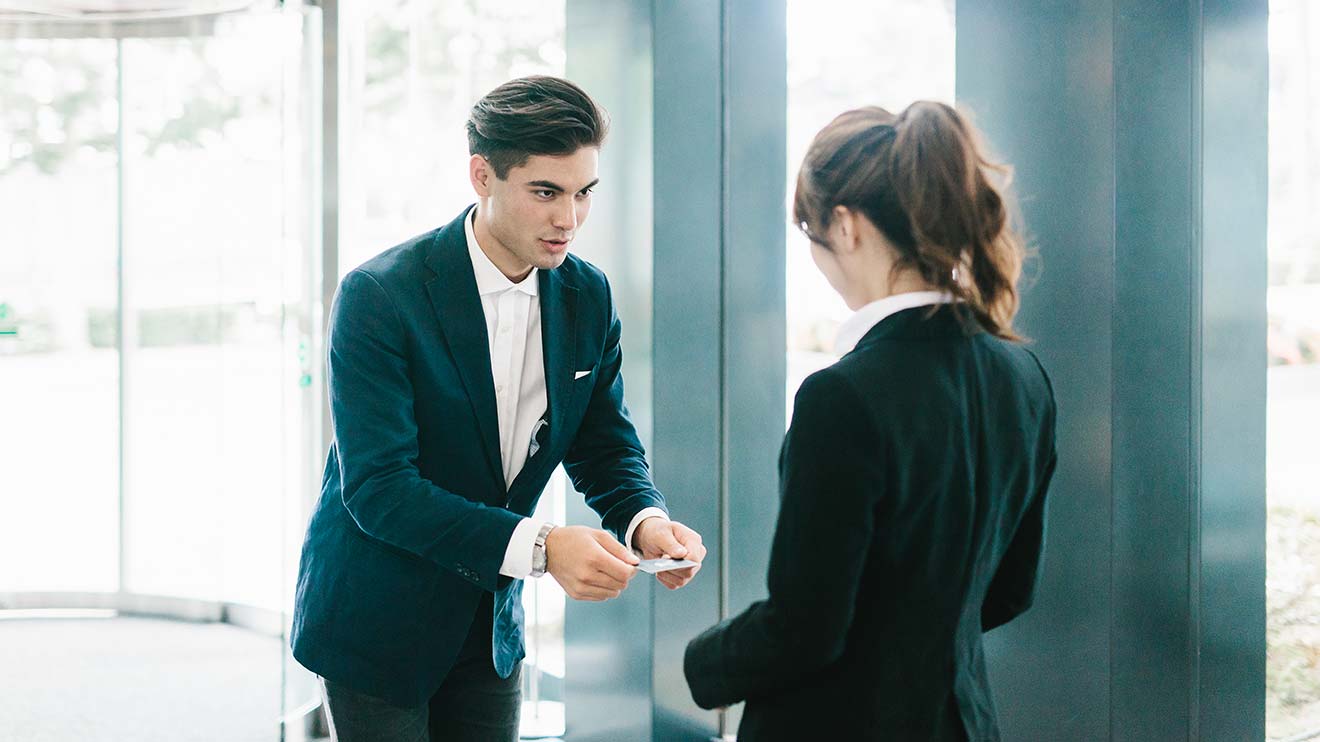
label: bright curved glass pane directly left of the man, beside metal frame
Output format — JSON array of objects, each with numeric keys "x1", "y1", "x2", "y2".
[{"x1": 121, "y1": 16, "x2": 310, "y2": 611}]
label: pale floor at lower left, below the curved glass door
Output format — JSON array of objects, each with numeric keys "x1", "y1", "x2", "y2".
[{"x1": 0, "y1": 618, "x2": 281, "y2": 742}]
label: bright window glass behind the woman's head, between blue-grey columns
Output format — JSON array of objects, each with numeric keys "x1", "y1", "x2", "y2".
[{"x1": 785, "y1": 0, "x2": 954, "y2": 420}]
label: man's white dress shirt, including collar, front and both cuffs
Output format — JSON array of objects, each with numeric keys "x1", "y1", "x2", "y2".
[{"x1": 463, "y1": 209, "x2": 665, "y2": 580}]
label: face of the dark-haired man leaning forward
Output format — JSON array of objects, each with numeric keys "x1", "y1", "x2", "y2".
[{"x1": 470, "y1": 147, "x2": 599, "y2": 279}]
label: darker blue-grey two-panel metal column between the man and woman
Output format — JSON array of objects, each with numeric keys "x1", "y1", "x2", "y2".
[{"x1": 653, "y1": 0, "x2": 787, "y2": 741}]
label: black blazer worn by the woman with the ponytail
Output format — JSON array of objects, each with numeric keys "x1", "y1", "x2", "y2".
[{"x1": 684, "y1": 306, "x2": 1055, "y2": 742}]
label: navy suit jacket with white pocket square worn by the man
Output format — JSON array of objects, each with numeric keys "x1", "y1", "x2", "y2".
[{"x1": 290, "y1": 204, "x2": 664, "y2": 706}]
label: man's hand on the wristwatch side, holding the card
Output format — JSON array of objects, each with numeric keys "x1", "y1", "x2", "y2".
[{"x1": 545, "y1": 525, "x2": 638, "y2": 601}]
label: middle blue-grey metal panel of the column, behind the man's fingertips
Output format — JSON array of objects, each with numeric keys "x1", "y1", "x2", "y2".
[{"x1": 652, "y1": 0, "x2": 725, "y2": 742}]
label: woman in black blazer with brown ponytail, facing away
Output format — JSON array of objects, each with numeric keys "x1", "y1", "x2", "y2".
[{"x1": 684, "y1": 102, "x2": 1055, "y2": 742}]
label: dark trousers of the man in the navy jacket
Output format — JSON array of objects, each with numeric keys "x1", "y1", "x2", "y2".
[{"x1": 321, "y1": 593, "x2": 523, "y2": 742}]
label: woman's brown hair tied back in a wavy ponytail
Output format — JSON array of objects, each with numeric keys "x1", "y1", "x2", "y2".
[{"x1": 793, "y1": 100, "x2": 1024, "y2": 341}]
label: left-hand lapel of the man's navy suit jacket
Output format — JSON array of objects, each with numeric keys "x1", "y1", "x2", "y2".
[{"x1": 426, "y1": 204, "x2": 504, "y2": 489}]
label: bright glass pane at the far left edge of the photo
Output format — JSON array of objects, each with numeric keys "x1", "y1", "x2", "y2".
[{"x1": 0, "y1": 38, "x2": 120, "y2": 593}]
